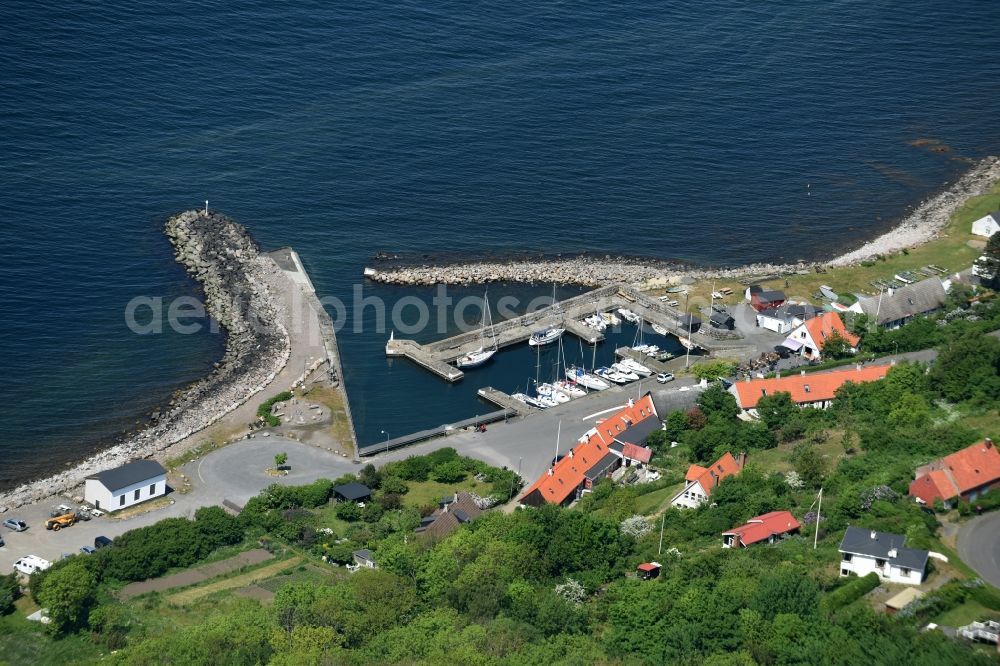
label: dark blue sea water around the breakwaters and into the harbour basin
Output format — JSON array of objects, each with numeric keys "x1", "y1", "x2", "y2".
[{"x1": 0, "y1": 0, "x2": 1000, "y2": 487}]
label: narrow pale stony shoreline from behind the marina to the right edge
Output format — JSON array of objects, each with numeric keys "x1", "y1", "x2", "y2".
[{"x1": 365, "y1": 157, "x2": 1000, "y2": 287}]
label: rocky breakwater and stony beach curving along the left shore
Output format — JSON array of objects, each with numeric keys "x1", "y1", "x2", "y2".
[{"x1": 0, "y1": 211, "x2": 291, "y2": 508}]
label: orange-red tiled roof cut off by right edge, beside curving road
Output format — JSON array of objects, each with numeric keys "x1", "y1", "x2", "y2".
[{"x1": 910, "y1": 439, "x2": 1000, "y2": 504}]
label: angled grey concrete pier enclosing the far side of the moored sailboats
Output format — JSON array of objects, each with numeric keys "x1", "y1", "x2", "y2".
[{"x1": 385, "y1": 285, "x2": 748, "y2": 382}]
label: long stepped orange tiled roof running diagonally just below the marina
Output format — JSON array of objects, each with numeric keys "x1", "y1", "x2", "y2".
[{"x1": 520, "y1": 393, "x2": 656, "y2": 504}]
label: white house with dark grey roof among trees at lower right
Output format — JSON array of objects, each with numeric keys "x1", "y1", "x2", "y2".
[{"x1": 840, "y1": 527, "x2": 929, "y2": 585}]
